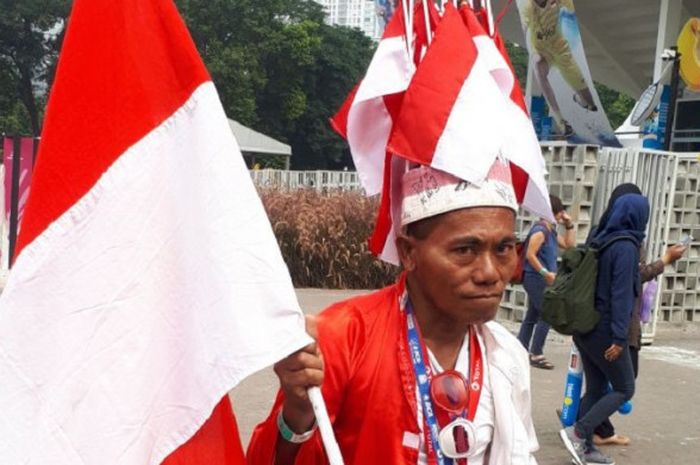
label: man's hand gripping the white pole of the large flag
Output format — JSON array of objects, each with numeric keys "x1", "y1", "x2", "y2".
[{"x1": 274, "y1": 315, "x2": 323, "y2": 434}]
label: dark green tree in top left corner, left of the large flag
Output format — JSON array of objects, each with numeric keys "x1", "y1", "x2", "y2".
[{"x1": 0, "y1": 0, "x2": 71, "y2": 135}]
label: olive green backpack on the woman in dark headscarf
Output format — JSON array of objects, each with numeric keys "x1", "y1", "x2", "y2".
[{"x1": 541, "y1": 236, "x2": 634, "y2": 335}]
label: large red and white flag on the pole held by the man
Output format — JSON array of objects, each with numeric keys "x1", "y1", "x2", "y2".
[{"x1": 0, "y1": 0, "x2": 308, "y2": 465}]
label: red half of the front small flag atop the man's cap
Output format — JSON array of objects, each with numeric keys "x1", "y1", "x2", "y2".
[{"x1": 388, "y1": 3, "x2": 477, "y2": 165}]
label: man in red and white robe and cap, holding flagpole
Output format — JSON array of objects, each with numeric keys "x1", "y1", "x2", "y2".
[{"x1": 248, "y1": 161, "x2": 538, "y2": 465}]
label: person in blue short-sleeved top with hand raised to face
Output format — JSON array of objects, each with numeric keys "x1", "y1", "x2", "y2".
[{"x1": 518, "y1": 195, "x2": 576, "y2": 370}]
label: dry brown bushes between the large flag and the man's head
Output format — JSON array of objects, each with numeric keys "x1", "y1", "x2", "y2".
[{"x1": 260, "y1": 189, "x2": 398, "y2": 289}]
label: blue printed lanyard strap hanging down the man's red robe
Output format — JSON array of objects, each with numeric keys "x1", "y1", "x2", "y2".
[{"x1": 405, "y1": 300, "x2": 453, "y2": 465}]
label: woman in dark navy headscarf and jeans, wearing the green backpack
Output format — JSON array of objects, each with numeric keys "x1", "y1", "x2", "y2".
[{"x1": 560, "y1": 194, "x2": 649, "y2": 465}]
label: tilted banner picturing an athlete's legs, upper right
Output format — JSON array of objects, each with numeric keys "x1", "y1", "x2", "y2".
[{"x1": 517, "y1": 0, "x2": 620, "y2": 147}]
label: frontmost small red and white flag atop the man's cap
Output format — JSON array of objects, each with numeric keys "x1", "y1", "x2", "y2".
[{"x1": 388, "y1": 3, "x2": 552, "y2": 218}]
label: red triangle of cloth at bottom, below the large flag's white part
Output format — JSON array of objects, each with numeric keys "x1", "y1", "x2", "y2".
[{"x1": 163, "y1": 396, "x2": 245, "y2": 465}]
